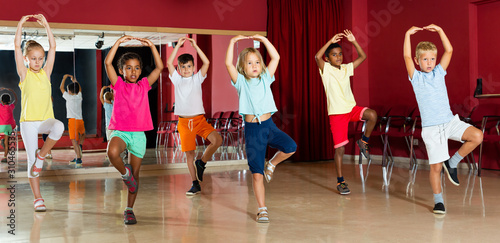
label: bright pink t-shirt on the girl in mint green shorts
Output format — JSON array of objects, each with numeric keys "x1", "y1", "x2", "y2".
[{"x1": 108, "y1": 77, "x2": 154, "y2": 132}]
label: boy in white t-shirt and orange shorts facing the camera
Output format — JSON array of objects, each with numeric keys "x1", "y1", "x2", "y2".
[{"x1": 167, "y1": 37, "x2": 222, "y2": 195}]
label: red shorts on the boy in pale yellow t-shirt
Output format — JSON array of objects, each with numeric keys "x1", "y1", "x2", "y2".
[{"x1": 328, "y1": 106, "x2": 368, "y2": 148}]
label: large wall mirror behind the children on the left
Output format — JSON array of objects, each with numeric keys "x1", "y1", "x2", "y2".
[{"x1": 0, "y1": 24, "x2": 254, "y2": 173}]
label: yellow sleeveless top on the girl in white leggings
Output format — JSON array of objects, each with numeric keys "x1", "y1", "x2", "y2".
[{"x1": 19, "y1": 68, "x2": 54, "y2": 122}]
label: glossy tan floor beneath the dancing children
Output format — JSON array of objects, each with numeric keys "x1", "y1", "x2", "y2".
[{"x1": 0, "y1": 157, "x2": 500, "y2": 243}]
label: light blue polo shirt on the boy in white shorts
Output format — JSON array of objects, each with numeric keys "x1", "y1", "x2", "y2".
[{"x1": 409, "y1": 64, "x2": 453, "y2": 127}]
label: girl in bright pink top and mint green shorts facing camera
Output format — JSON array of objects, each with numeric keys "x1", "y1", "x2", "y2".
[{"x1": 104, "y1": 36, "x2": 163, "y2": 224}]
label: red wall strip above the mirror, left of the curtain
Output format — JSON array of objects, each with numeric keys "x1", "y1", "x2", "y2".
[{"x1": 0, "y1": 0, "x2": 267, "y2": 31}]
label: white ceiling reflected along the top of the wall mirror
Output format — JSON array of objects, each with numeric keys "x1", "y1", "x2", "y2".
[{"x1": 0, "y1": 27, "x2": 186, "y2": 52}]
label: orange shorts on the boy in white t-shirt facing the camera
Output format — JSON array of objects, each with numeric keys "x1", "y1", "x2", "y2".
[{"x1": 177, "y1": 115, "x2": 215, "y2": 152}]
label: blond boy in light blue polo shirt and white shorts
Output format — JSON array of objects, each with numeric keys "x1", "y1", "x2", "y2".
[{"x1": 403, "y1": 24, "x2": 483, "y2": 214}]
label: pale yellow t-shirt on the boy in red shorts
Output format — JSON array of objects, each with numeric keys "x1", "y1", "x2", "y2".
[{"x1": 319, "y1": 62, "x2": 356, "y2": 115}]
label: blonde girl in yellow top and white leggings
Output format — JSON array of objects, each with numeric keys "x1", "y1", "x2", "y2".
[{"x1": 14, "y1": 14, "x2": 64, "y2": 212}]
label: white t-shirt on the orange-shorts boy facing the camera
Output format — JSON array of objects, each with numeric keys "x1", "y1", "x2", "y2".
[{"x1": 169, "y1": 71, "x2": 207, "y2": 116}]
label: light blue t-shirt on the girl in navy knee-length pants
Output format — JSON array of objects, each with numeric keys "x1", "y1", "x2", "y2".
[{"x1": 231, "y1": 69, "x2": 278, "y2": 123}]
